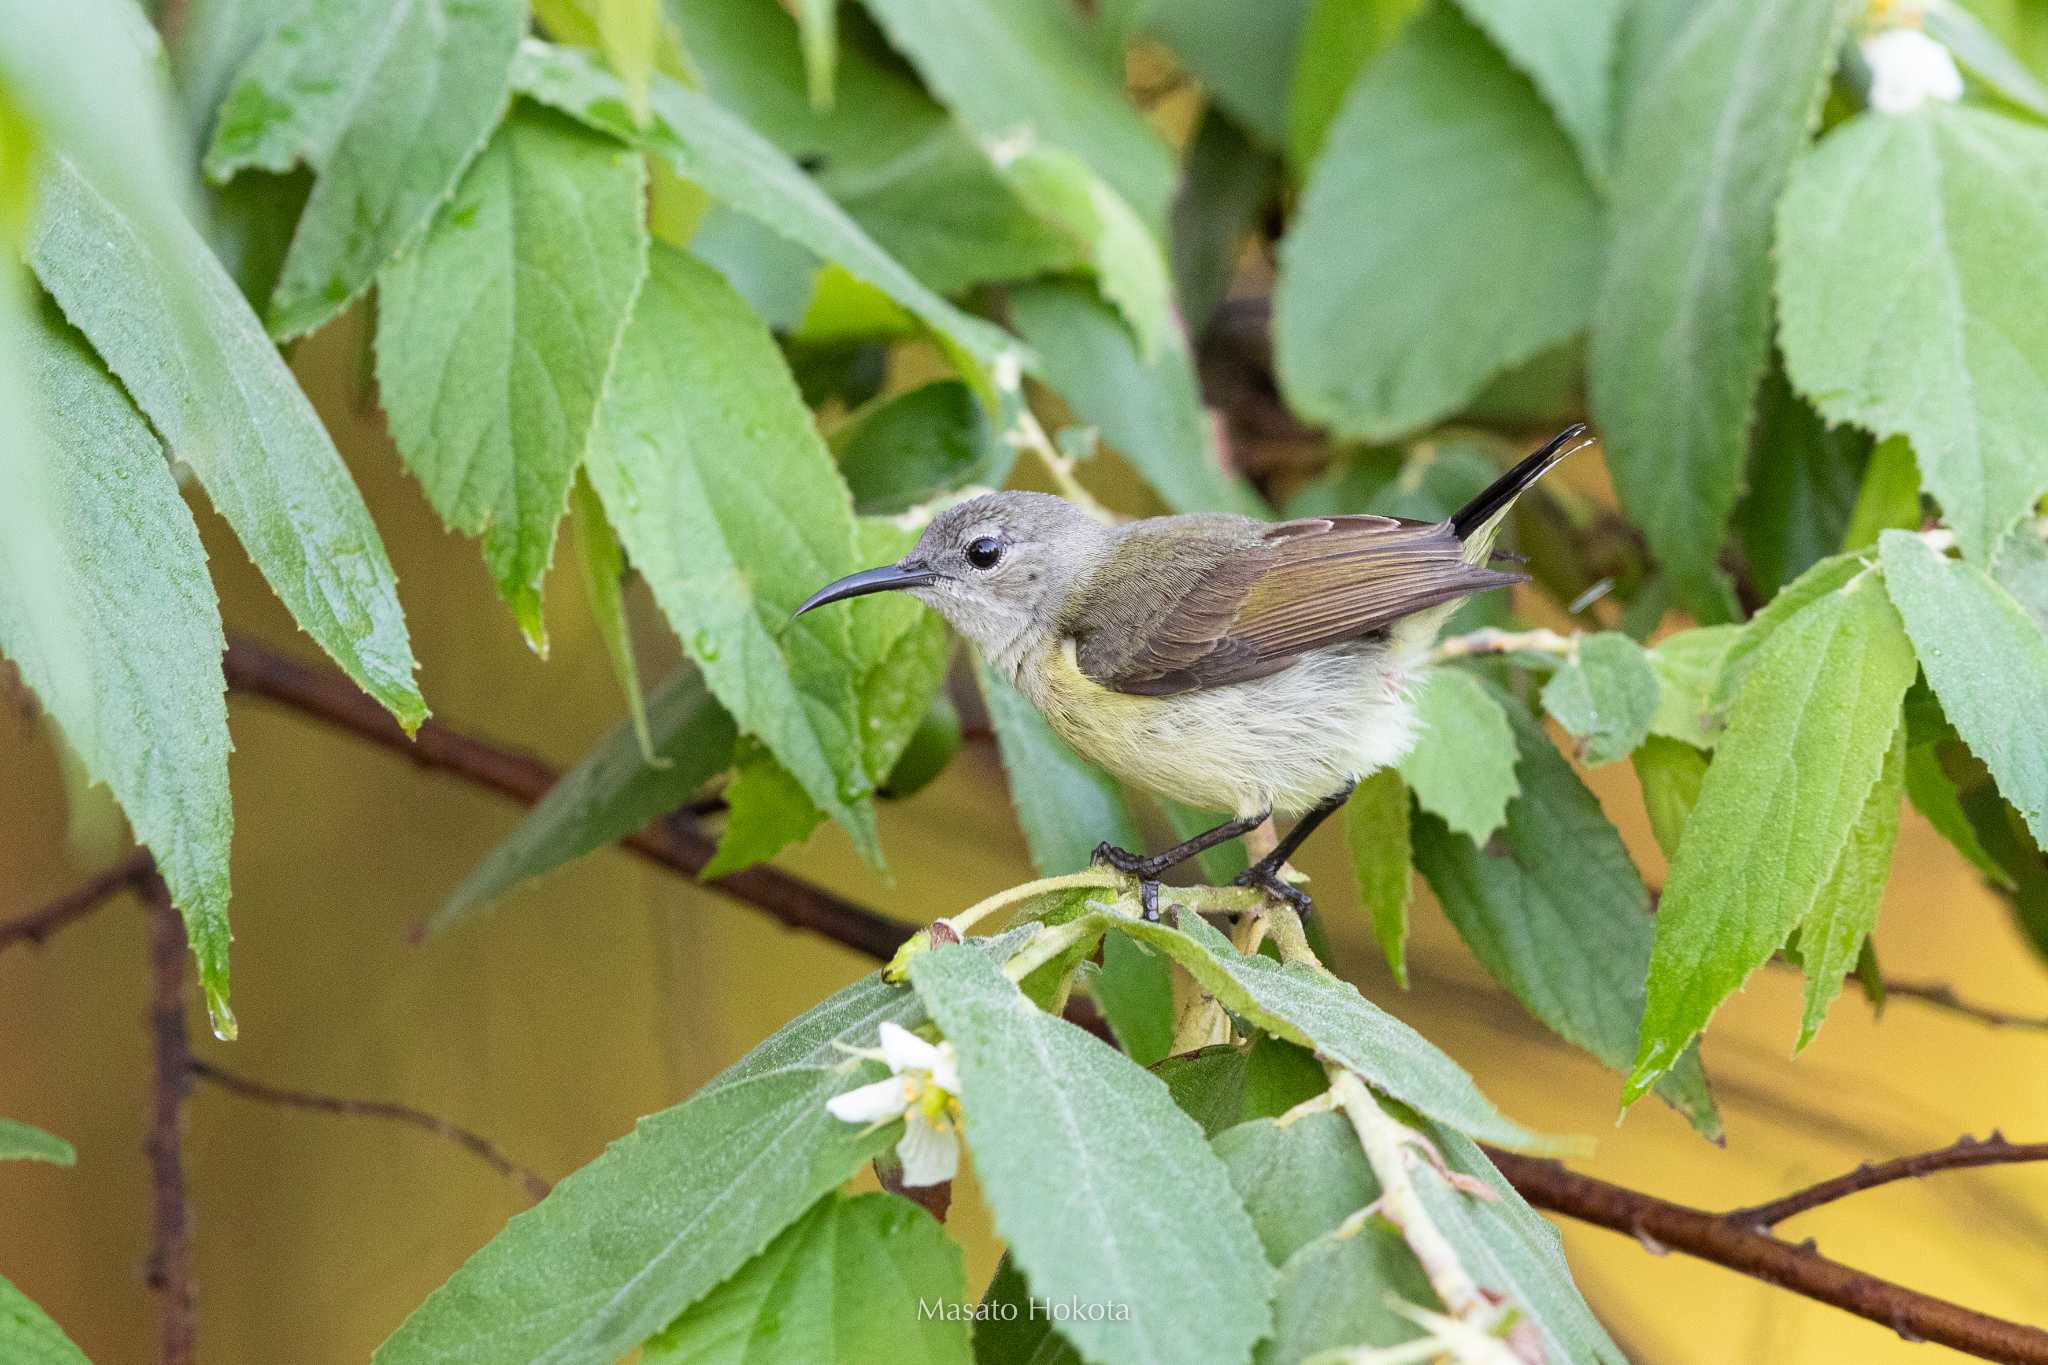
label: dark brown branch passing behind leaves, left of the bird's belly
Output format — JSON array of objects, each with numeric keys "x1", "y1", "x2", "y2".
[{"x1": 225, "y1": 636, "x2": 911, "y2": 962}]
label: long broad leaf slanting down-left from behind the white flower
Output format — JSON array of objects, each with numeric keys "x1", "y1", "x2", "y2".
[{"x1": 375, "y1": 970, "x2": 954, "y2": 1365}]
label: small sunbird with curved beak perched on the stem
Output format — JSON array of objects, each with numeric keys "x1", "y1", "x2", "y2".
[{"x1": 797, "y1": 424, "x2": 1593, "y2": 913}]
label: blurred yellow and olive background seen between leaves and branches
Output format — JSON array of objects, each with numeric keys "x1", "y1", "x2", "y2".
[{"x1": 0, "y1": 317, "x2": 2048, "y2": 1365}]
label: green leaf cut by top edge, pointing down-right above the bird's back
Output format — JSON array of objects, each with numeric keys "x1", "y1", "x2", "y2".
[{"x1": 851, "y1": 0, "x2": 1174, "y2": 225}]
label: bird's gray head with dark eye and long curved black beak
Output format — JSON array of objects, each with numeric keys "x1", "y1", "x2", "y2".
[{"x1": 797, "y1": 493, "x2": 1114, "y2": 671}]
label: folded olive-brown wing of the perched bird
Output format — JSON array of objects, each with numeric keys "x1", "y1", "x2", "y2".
[{"x1": 1079, "y1": 516, "x2": 1522, "y2": 696}]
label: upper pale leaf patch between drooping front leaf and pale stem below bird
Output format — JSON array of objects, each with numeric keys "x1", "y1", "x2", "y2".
[{"x1": 1212, "y1": 1111, "x2": 1380, "y2": 1267}]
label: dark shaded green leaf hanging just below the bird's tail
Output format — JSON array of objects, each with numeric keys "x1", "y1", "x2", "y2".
[{"x1": 1415, "y1": 706, "x2": 1720, "y2": 1140}]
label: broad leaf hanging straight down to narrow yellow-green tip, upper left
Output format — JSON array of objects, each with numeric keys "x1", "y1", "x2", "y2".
[{"x1": 377, "y1": 104, "x2": 647, "y2": 653}]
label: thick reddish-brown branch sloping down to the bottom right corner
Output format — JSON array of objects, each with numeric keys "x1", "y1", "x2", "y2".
[{"x1": 1487, "y1": 1148, "x2": 2048, "y2": 1365}]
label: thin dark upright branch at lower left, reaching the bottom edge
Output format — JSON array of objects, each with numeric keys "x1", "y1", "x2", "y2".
[{"x1": 143, "y1": 870, "x2": 199, "y2": 1365}]
